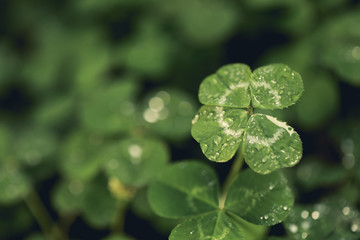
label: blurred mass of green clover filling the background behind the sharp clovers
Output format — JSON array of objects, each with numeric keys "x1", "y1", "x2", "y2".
[{"x1": 0, "y1": 0, "x2": 360, "y2": 240}]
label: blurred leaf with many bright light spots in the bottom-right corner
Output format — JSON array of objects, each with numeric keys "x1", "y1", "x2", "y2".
[{"x1": 284, "y1": 188, "x2": 360, "y2": 239}]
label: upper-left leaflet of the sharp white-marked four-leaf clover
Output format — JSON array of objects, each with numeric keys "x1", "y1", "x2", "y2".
[{"x1": 199, "y1": 64, "x2": 253, "y2": 108}]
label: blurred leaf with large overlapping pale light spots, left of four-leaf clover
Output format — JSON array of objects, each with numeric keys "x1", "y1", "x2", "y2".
[{"x1": 142, "y1": 89, "x2": 196, "y2": 140}]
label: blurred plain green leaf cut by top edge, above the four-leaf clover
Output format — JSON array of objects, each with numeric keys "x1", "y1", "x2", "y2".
[{"x1": 161, "y1": 0, "x2": 241, "y2": 45}]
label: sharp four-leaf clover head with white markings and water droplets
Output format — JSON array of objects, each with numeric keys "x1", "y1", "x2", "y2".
[{"x1": 191, "y1": 64, "x2": 303, "y2": 174}]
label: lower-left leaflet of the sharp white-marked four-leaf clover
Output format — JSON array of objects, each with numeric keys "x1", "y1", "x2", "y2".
[{"x1": 191, "y1": 105, "x2": 248, "y2": 162}]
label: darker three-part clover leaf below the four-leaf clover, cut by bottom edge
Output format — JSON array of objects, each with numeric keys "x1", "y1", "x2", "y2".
[{"x1": 148, "y1": 160, "x2": 294, "y2": 240}]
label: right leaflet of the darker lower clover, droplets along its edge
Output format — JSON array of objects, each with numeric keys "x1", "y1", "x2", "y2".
[{"x1": 225, "y1": 169, "x2": 294, "y2": 226}]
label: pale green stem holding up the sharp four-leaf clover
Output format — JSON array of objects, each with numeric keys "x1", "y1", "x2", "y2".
[{"x1": 219, "y1": 147, "x2": 244, "y2": 209}]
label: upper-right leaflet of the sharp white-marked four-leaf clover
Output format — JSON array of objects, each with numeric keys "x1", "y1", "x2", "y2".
[{"x1": 250, "y1": 64, "x2": 304, "y2": 109}]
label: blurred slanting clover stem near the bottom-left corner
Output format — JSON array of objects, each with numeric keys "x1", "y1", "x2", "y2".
[{"x1": 23, "y1": 190, "x2": 67, "y2": 240}]
